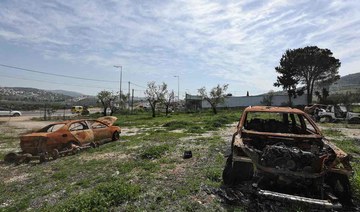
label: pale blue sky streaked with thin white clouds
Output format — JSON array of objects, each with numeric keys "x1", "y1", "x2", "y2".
[{"x1": 0, "y1": 0, "x2": 360, "y2": 98}]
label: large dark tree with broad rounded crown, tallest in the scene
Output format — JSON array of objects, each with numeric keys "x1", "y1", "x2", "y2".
[{"x1": 275, "y1": 46, "x2": 341, "y2": 104}]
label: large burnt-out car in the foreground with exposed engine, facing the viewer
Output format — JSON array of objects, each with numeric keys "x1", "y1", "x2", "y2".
[{"x1": 223, "y1": 106, "x2": 353, "y2": 208}]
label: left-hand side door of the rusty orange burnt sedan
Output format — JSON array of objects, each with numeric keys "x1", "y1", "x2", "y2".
[{"x1": 69, "y1": 121, "x2": 94, "y2": 145}]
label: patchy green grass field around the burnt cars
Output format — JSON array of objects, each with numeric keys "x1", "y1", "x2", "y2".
[{"x1": 0, "y1": 111, "x2": 360, "y2": 211}]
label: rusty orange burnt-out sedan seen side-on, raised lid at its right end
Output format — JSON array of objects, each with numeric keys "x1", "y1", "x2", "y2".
[{"x1": 4, "y1": 116, "x2": 121, "y2": 162}]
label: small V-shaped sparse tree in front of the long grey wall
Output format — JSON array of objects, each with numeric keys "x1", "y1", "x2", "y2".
[{"x1": 198, "y1": 84, "x2": 229, "y2": 114}]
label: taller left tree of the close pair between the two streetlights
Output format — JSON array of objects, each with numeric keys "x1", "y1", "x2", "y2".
[{"x1": 145, "y1": 81, "x2": 167, "y2": 117}]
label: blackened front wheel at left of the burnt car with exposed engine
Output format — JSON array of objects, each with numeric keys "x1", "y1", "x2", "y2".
[{"x1": 222, "y1": 155, "x2": 254, "y2": 186}]
